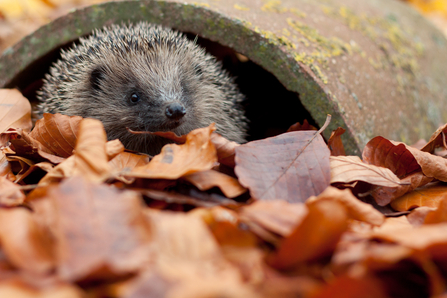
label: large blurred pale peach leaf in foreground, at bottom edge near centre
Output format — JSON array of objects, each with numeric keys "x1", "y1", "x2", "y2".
[{"x1": 146, "y1": 209, "x2": 258, "y2": 298}]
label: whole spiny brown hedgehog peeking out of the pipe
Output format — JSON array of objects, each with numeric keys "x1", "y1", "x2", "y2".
[{"x1": 36, "y1": 22, "x2": 247, "y2": 155}]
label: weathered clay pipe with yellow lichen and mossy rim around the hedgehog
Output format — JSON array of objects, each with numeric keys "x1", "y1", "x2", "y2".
[{"x1": 0, "y1": 0, "x2": 447, "y2": 154}]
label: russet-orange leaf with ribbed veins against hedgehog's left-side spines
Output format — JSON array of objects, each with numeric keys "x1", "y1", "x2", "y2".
[{"x1": 29, "y1": 113, "x2": 82, "y2": 158}]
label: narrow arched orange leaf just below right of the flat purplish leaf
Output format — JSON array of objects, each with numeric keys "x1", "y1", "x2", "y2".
[{"x1": 306, "y1": 186, "x2": 385, "y2": 226}]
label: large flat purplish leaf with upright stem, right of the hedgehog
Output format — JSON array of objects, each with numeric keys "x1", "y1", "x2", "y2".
[{"x1": 235, "y1": 131, "x2": 330, "y2": 203}]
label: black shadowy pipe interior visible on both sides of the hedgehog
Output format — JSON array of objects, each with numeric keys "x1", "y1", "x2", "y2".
[{"x1": 6, "y1": 34, "x2": 317, "y2": 141}]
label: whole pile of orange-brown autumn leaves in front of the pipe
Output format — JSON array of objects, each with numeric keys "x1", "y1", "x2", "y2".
[{"x1": 0, "y1": 90, "x2": 447, "y2": 298}]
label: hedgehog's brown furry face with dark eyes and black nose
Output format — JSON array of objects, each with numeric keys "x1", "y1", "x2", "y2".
[{"x1": 78, "y1": 44, "x2": 224, "y2": 155}]
